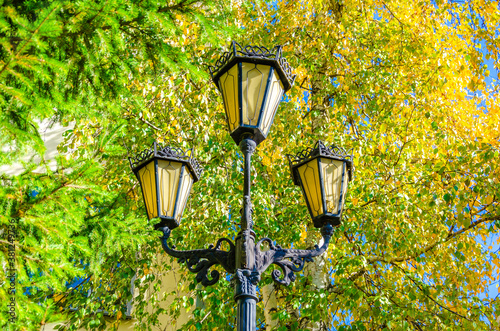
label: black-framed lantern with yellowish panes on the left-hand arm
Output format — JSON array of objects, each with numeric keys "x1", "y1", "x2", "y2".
[{"x1": 129, "y1": 142, "x2": 203, "y2": 229}]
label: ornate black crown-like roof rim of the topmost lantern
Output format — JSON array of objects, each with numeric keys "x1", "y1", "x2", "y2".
[{"x1": 208, "y1": 41, "x2": 297, "y2": 92}]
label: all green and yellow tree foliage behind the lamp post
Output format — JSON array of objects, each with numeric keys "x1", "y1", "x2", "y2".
[{"x1": 0, "y1": 0, "x2": 500, "y2": 330}]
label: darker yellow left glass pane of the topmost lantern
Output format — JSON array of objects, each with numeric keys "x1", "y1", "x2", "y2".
[{"x1": 219, "y1": 64, "x2": 240, "y2": 132}]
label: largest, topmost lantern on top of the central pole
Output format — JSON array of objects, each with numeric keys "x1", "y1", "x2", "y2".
[{"x1": 209, "y1": 41, "x2": 296, "y2": 144}]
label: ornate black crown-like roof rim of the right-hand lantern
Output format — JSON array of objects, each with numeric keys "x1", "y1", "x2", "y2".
[{"x1": 287, "y1": 140, "x2": 354, "y2": 185}]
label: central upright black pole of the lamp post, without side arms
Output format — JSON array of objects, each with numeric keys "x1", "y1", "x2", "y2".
[{"x1": 234, "y1": 139, "x2": 257, "y2": 331}]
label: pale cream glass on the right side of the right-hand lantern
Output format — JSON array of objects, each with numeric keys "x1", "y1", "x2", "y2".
[{"x1": 321, "y1": 158, "x2": 347, "y2": 214}]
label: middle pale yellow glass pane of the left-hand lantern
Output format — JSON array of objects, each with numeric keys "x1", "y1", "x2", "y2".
[{"x1": 158, "y1": 160, "x2": 182, "y2": 217}]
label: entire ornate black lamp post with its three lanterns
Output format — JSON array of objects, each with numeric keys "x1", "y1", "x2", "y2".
[{"x1": 129, "y1": 42, "x2": 353, "y2": 331}]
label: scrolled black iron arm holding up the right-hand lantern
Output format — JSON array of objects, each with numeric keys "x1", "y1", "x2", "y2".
[{"x1": 255, "y1": 223, "x2": 333, "y2": 285}]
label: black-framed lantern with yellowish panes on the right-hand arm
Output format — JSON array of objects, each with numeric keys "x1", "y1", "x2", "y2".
[{"x1": 287, "y1": 141, "x2": 353, "y2": 228}]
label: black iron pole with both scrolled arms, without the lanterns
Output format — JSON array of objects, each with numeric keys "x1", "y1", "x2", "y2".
[{"x1": 154, "y1": 136, "x2": 338, "y2": 331}]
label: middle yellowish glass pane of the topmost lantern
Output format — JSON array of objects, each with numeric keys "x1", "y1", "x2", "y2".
[{"x1": 241, "y1": 63, "x2": 271, "y2": 125}]
